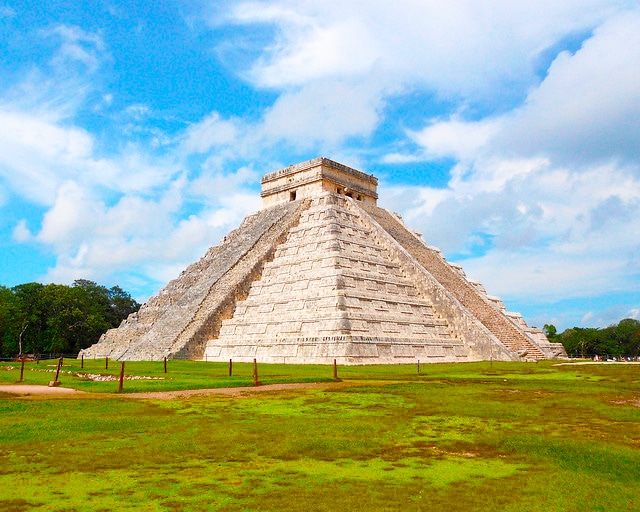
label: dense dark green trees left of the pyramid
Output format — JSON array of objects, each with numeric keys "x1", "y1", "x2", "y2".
[{"x1": 0, "y1": 279, "x2": 140, "y2": 357}]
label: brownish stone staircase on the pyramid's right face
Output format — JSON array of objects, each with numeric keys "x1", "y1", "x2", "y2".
[{"x1": 361, "y1": 205, "x2": 547, "y2": 360}]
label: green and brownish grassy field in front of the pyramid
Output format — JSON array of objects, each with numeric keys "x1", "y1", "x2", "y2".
[{"x1": 0, "y1": 360, "x2": 640, "y2": 512}]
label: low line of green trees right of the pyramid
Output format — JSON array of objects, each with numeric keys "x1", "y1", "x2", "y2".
[{"x1": 545, "y1": 318, "x2": 640, "y2": 358}]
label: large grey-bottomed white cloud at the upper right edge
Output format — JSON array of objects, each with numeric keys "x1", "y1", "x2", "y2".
[{"x1": 496, "y1": 11, "x2": 640, "y2": 165}]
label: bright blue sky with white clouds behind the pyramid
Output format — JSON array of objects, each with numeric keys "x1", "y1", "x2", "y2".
[{"x1": 0, "y1": 0, "x2": 640, "y2": 329}]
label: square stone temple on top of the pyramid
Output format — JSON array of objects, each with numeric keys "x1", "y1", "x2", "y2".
[{"x1": 260, "y1": 157, "x2": 378, "y2": 208}]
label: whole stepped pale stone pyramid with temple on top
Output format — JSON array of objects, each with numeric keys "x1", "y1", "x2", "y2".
[{"x1": 83, "y1": 158, "x2": 566, "y2": 364}]
